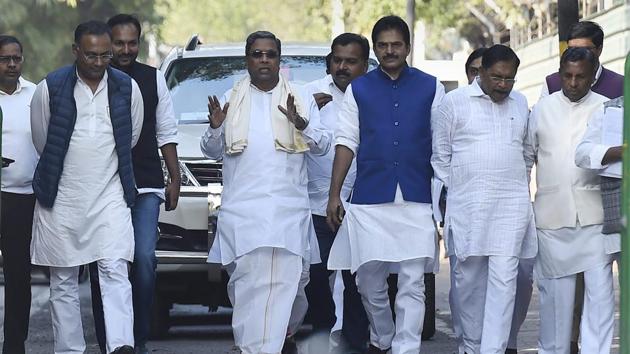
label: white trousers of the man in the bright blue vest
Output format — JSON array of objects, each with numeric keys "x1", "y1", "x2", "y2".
[{"x1": 356, "y1": 258, "x2": 427, "y2": 354}]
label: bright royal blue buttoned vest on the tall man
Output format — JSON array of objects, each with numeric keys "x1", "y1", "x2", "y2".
[{"x1": 351, "y1": 67, "x2": 436, "y2": 204}]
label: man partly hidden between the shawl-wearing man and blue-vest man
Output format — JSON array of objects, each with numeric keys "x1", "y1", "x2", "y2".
[{"x1": 289, "y1": 33, "x2": 370, "y2": 353}]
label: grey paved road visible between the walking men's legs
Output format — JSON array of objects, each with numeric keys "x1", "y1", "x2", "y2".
[{"x1": 0, "y1": 254, "x2": 619, "y2": 354}]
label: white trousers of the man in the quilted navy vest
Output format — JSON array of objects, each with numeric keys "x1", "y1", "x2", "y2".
[{"x1": 50, "y1": 259, "x2": 134, "y2": 354}]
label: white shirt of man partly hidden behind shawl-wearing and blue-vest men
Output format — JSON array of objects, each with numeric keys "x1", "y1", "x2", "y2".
[{"x1": 305, "y1": 75, "x2": 357, "y2": 216}]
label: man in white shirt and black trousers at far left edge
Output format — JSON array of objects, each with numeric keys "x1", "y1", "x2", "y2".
[{"x1": 0, "y1": 36, "x2": 38, "y2": 354}]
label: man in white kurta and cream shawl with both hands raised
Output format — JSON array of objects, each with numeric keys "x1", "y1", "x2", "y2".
[{"x1": 201, "y1": 31, "x2": 331, "y2": 354}]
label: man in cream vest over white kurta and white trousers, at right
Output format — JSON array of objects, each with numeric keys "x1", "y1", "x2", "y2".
[{"x1": 528, "y1": 48, "x2": 614, "y2": 354}]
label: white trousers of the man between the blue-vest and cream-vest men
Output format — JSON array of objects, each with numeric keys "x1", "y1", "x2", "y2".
[{"x1": 455, "y1": 256, "x2": 519, "y2": 354}]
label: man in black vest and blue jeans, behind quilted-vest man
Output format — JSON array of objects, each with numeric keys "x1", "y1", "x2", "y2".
[{"x1": 90, "y1": 14, "x2": 181, "y2": 354}]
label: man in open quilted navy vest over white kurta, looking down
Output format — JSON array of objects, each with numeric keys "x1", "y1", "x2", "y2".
[{"x1": 31, "y1": 21, "x2": 143, "y2": 354}]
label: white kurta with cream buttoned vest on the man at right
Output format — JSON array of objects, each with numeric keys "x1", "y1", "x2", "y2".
[{"x1": 528, "y1": 91, "x2": 611, "y2": 278}]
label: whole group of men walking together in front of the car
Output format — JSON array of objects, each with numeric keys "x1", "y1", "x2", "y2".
[{"x1": 0, "y1": 9, "x2": 623, "y2": 354}]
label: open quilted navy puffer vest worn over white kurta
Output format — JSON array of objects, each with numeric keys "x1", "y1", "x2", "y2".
[{"x1": 33, "y1": 65, "x2": 136, "y2": 208}]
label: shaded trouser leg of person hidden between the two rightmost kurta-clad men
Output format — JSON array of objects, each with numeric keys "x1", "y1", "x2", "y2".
[{"x1": 507, "y1": 258, "x2": 536, "y2": 349}]
